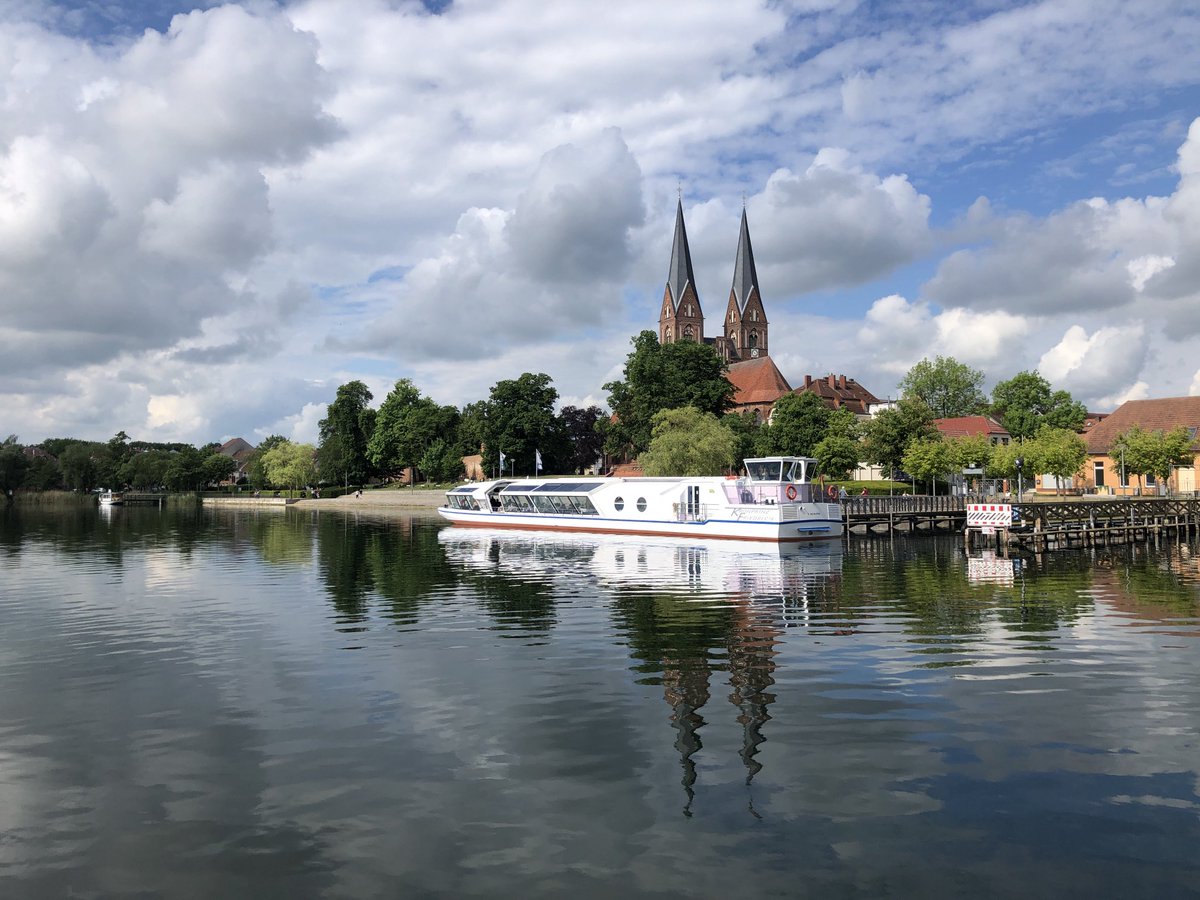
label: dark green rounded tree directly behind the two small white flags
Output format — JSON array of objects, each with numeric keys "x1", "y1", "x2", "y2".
[{"x1": 484, "y1": 372, "x2": 566, "y2": 475}]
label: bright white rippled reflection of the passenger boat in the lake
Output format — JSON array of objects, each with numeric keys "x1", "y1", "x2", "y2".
[{"x1": 438, "y1": 527, "x2": 842, "y2": 599}]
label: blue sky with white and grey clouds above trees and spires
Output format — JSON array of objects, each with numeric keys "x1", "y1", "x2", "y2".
[{"x1": 0, "y1": 0, "x2": 1200, "y2": 444}]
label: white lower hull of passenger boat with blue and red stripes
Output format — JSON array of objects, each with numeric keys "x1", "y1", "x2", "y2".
[{"x1": 438, "y1": 506, "x2": 842, "y2": 544}]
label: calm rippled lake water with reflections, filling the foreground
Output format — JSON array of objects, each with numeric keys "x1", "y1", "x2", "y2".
[{"x1": 0, "y1": 506, "x2": 1200, "y2": 898}]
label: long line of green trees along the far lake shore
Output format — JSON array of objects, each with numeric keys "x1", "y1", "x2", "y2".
[{"x1": 0, "y1": 340, "x2": 1193, "y2": 501}]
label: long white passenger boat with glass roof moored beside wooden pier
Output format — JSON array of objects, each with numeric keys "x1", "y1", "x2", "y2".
[{"x1": 438, "y1": 456, "x2": 842, "y2": 541}]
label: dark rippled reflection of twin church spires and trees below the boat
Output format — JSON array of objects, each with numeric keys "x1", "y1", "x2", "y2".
[{"x1": 613, "y1": 590, "x2": 780, "y2": 815}]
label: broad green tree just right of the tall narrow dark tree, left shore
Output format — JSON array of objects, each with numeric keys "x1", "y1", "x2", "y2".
[{"x1": 367, "y1": 378, "x2": 458, "y2": 481}]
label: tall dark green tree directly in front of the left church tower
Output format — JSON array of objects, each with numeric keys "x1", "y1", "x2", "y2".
[{"x1": 604, "y1": 331, "x2": 734, "y2": 456}]
